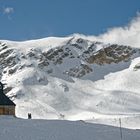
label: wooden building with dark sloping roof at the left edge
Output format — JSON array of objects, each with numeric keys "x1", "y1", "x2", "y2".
[{"x1": 0, "y1": 82, "x2": 16, "y2": 116}]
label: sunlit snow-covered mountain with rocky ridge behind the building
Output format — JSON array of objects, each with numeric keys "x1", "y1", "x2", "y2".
[{"x1": 0, "y1": 35, "x2": 140, "y2": 128}]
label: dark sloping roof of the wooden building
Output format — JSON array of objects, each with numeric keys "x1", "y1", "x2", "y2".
[{"x1": 0, "y1": 82, "x2": 16, "y2": 106}]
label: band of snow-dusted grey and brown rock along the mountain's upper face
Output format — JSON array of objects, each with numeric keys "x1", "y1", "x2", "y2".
[{"x1": 0, "y1": 38, "x2": 137, "y2": 81}]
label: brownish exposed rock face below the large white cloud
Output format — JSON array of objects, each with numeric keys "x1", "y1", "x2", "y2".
[{"x1": 87, "y1": 44, "x2": 136, "y2": 65}]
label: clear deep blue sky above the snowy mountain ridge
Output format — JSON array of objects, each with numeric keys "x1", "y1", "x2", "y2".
[{"x1": 0, "y1": 0, "x2": 140, "y2": 40}]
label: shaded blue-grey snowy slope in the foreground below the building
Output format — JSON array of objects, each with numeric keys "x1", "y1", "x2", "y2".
[{"x1": 0, "y1": 117, "x2": 140, "y2": 140}]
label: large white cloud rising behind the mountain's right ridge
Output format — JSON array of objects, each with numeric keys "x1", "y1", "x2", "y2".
[{"x1": 81, "y1": 13, "x2": 140, "y2": 48}]
